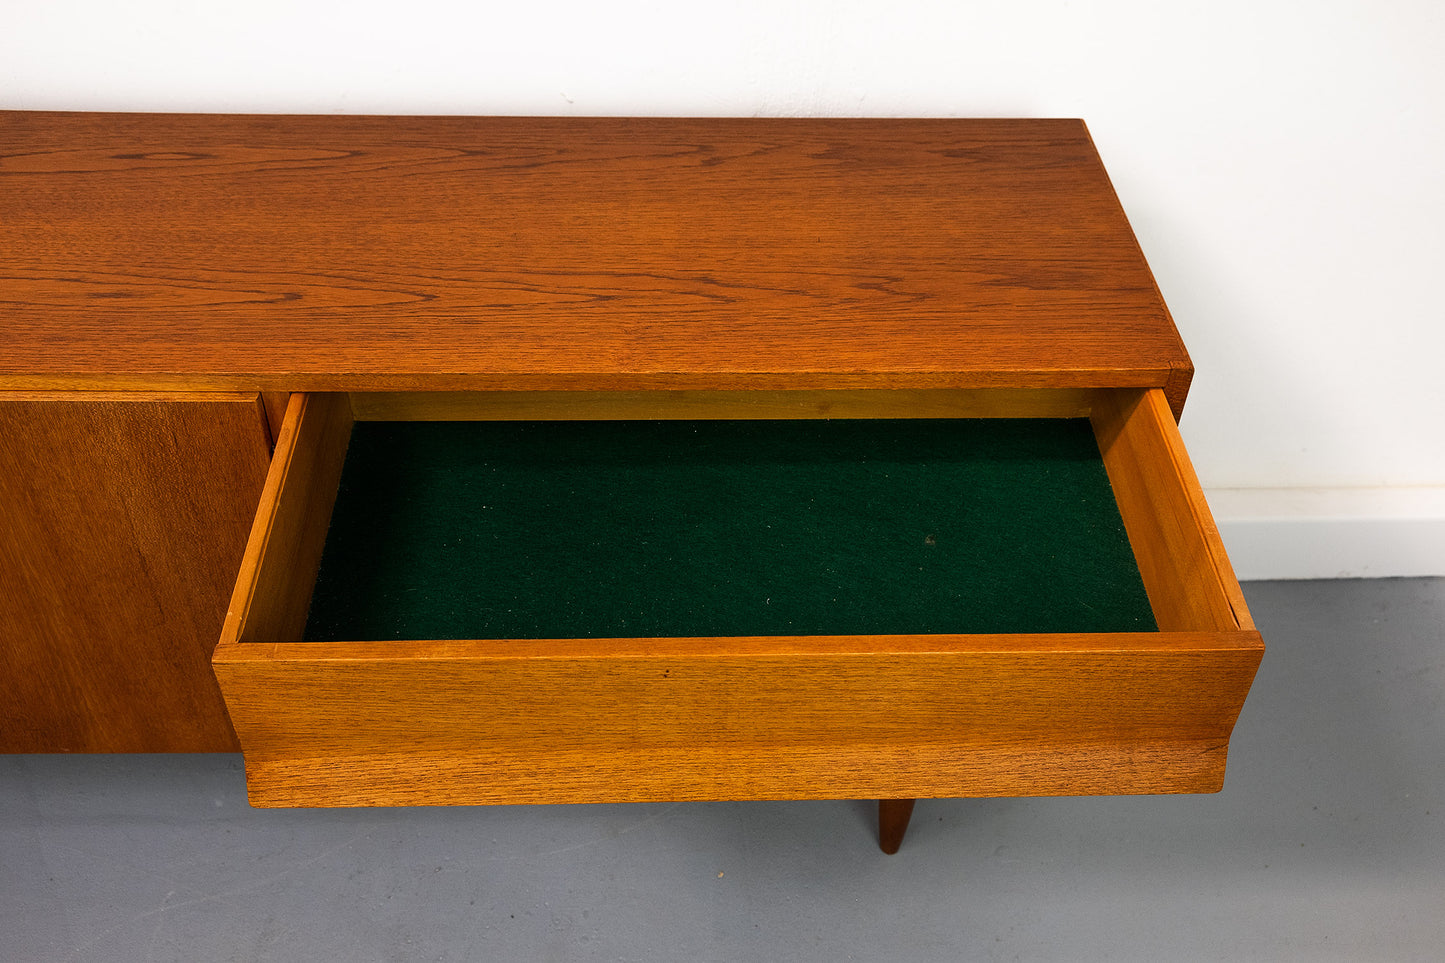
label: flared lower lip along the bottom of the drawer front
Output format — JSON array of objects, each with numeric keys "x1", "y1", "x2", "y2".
[{"x1": 236, "y1": 740, "x2": 1254, "y2": 807}]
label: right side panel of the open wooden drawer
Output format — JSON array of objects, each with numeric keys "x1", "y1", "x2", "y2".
[{"x1": 1092, "y1": 390, "x2": 1254, "y2": 632}]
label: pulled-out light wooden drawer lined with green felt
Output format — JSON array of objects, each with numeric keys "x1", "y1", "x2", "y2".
[{"x1": 214, "y1": 389, "x2": 1263, "y2": 805}]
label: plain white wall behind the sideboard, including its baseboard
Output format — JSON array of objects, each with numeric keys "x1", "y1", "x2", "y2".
[{"x1": 0, "y1": 0, "x2": 1445, "y2": 577}]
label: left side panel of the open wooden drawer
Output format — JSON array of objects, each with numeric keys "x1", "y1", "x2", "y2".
[{"x1": 221, "y1": 393, "x2": 351, "y2": 645}]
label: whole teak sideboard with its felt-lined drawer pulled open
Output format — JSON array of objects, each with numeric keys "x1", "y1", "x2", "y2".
[{"x1": 0, "y1": 111, "x2": 1263, "y2": 850}]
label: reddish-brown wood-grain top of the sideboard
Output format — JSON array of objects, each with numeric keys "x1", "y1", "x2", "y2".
[{"x1": 0, "y1": 111, "x2": 1192, "y2": 409}]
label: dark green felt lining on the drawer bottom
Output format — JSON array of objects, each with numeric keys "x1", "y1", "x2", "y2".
[{"x1": 306, "y1": 419, "x2": 1155, "y2": 641}]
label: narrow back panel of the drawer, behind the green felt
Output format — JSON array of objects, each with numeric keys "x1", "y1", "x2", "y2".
[{"x1": 351, "y1": 389, "x2": 1094, "y2": 421}]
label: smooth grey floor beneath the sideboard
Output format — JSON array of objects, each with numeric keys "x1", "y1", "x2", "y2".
[{"x1": 0, "y1": 578, "x2": 1445, "y2": 963}]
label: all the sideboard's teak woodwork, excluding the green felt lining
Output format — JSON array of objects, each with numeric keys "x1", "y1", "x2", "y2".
[{"x1": 0, "y1": 111, "x2": 1263, "y2": 852}]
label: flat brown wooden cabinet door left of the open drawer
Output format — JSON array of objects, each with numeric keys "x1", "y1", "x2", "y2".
[{"x1": 0, "y1": 393, "x2": 270, "y2": 752}]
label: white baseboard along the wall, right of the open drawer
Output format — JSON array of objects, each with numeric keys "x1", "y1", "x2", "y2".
[{"x1": 1205, "y1": 486, "x2": 1445, "y2": 580}]
